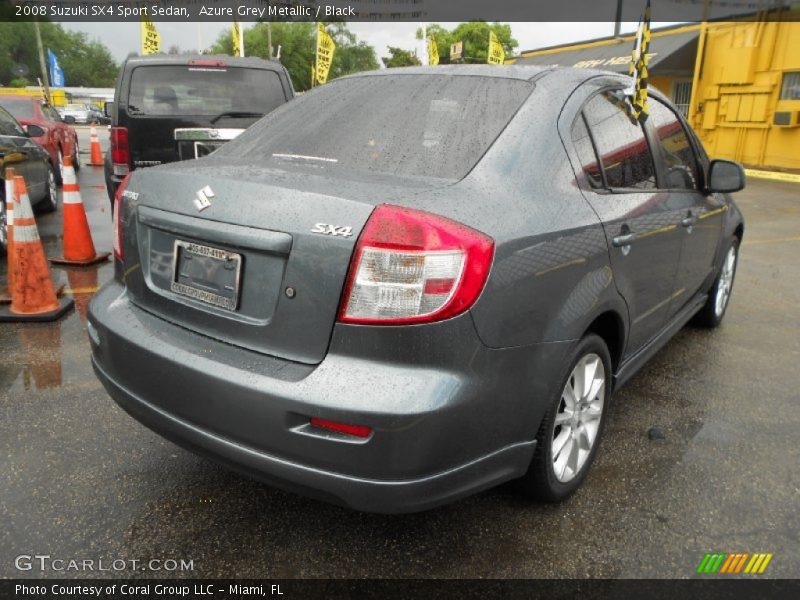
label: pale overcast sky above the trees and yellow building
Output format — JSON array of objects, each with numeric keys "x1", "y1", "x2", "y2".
[{"x1": 62, "y1": 22, "x2": 648, "y2": 61}]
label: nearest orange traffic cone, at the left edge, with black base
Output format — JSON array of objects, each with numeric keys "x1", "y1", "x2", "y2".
[{"x1": 0, "y1": 175, "x2": 75, "y2": 322}]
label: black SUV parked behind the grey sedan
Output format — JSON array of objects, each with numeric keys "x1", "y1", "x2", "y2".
[{"x1": 105, "y1": 54, "x2": 294, "y2": 206}]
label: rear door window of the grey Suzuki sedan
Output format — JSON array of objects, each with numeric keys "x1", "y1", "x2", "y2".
[{"x1": 583, "y1": 92, "x2": 656, "y2": 190}]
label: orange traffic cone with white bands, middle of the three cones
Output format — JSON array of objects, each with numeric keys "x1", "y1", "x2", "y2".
[{"x1": 50, "y1": 156, "x2": 111, "y2": 267}]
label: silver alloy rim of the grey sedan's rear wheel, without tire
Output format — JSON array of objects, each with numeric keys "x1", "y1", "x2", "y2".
[{"x1": 551, "y1": 353, "x2": 606, "y2": 483}]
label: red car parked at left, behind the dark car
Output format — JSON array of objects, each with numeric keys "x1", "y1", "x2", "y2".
[{"x1": 0, "y1": 95, "x2": 81, "y2": 184}]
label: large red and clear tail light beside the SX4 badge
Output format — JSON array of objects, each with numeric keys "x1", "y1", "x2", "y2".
[{"x1": 339, "y1": 204, "x2": 494, "y2": 325}]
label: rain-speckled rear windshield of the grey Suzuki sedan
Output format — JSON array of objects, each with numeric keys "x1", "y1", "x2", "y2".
[{"x1": 216, "y1": 75, "x2": 531, "y2": 179}]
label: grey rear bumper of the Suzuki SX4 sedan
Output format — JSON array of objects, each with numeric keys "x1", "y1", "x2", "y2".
[{"x1": 89, "y1": 282, "x2": 568, "y2": 512}]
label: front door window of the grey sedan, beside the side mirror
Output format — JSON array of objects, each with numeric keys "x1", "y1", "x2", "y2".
[{"x1": 648, "y1": 99, "x2": 699, "y2": 190}]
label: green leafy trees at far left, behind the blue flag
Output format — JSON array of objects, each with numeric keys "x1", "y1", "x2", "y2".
[{"x1": 0, "y1": 22, "x2": 119, "y2": 87}]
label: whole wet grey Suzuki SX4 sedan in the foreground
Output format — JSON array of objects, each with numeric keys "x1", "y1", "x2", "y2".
[{"x1": 89, "y1": 66, "x2": 744, "y2": 512}]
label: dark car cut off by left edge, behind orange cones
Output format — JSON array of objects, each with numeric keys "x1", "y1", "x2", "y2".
[{"x1": 0, "y1": 107, "x2": 58, "y2": 256}]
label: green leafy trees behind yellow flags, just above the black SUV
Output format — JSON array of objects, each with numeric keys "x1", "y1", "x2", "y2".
[{"x1": 210, "y1": 22, "x2": 379, "y2": 91}]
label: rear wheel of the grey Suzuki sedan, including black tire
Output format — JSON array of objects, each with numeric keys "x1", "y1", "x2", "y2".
[{"x1": 520, "y1": 334, "x2": 612, "y2": 502}]
